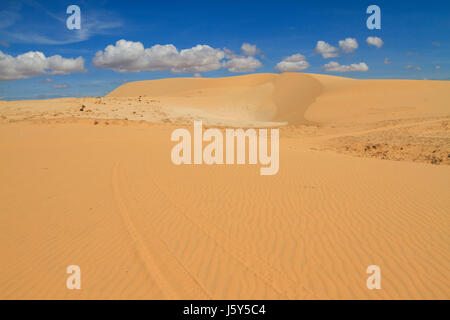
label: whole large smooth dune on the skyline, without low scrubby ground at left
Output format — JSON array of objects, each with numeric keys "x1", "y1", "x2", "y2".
[{"x1": 106, "y1": 73, "x2": 450, "y2": 125}]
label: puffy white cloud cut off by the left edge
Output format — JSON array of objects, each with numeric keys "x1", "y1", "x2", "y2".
[{"x1": 0, "y1": 51, "x2": 85, "y2": 81}]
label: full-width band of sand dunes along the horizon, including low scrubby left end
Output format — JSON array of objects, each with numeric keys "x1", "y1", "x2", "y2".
[{"x1": 0, "y1": 73, "x2": 450, "y2": 127}]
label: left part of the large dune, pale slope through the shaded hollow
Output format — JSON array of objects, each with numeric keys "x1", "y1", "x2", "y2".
[{"x1": 106, "y1": 73, "x2": 322, "y2": 124}]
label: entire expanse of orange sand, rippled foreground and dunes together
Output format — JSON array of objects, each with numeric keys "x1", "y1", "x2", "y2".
[{"x1": 0, "y1": 74, "x2": 450, "y2": 299}]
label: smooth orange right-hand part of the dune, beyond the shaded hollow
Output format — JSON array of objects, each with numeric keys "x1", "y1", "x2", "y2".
[{"x1": 305, "y1": 75, "x2": 450, "y2": 123}]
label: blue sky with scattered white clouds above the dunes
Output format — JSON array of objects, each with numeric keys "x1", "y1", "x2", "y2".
[{"x1": 0, "y1": 0, "x2": 450, "y2": 100}]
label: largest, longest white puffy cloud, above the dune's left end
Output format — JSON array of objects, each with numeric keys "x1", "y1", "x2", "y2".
[{"x1": 93, "y1": 39, "x2": 225, "y2": 72}]
